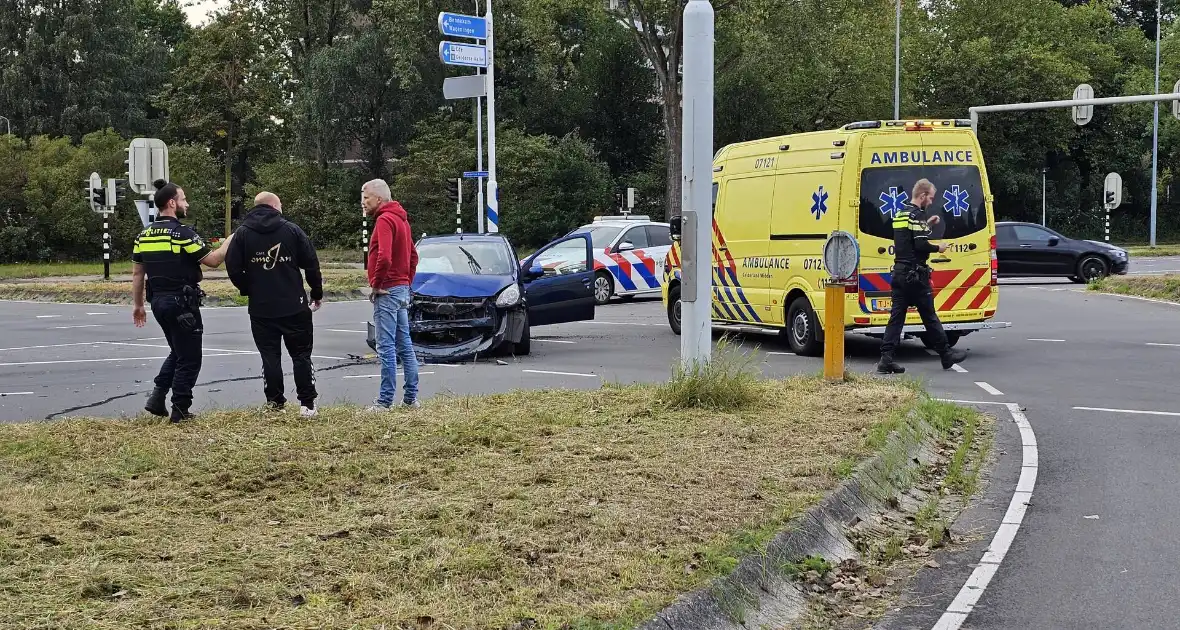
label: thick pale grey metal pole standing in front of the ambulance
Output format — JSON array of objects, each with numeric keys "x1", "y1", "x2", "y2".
[{"x1": 680, "y1": 0, "x2": 714, "y2": 367}]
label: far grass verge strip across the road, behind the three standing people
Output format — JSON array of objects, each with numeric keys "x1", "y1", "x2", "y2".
[{"x1": 0, "y1": 269, "x2": 368, "y2": 307}]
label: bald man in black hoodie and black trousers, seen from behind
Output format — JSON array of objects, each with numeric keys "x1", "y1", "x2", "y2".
[{"x1": 225, "y1": 192, "x2": 323, "y2": 416}]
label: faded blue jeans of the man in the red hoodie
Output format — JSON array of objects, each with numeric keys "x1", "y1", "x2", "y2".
[{"x1": 373, "y1": 287, "x2": 418, "y2": 407}]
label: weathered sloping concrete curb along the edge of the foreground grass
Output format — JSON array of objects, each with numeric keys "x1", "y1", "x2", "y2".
[{"x1": 637, "y1": 413, "x2": 935, "y2": 630}]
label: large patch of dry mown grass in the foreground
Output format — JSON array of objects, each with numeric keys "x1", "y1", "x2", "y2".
[{"x1": 0, "y1": 376, "x2": 918, "y2": 629}]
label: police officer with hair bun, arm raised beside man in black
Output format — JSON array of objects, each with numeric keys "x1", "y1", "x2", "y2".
[{"x1": 131, "y1": 179, "x2": 232, "y2": 422}]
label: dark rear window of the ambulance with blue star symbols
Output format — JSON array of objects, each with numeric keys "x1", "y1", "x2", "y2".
[{"x1": 860, "y1": 165, "x2": 988, "y2": 241}]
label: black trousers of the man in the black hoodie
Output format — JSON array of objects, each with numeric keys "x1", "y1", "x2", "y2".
[{"x1": 250, "y1": 309, "x2": 316, "y2": 408}]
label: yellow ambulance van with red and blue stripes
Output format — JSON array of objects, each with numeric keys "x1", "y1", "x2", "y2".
[{"x1": 663, "y1": 120, "x2": 1010, "y2": 355}]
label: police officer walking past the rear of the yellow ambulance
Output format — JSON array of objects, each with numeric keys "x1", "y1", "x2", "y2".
[{"x1": 877, "y1": 179, "x2": 966, "y2": 374}]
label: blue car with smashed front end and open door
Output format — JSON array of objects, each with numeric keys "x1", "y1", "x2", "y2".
[{"x1": 368, "y1": 234, "x2": 595, "y2": 362}]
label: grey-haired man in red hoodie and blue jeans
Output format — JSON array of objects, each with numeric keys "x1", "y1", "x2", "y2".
[{"x1": 361, "y1": 179, "x2": 419, "y2": 412}]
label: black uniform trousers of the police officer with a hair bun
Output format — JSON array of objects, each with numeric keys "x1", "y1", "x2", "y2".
[{"x1": 151, "y1": 295, "x2": 205, "y2": 412}]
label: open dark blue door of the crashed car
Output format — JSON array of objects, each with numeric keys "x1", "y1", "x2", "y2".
[{"x1": 520, "y1": 232, "x2": 595, "y2": 326}]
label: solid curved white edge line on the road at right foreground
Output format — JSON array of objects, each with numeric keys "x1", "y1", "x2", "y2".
[{"x1": 933, "y1": 402, "x2": 1038, "y2": 630}]
